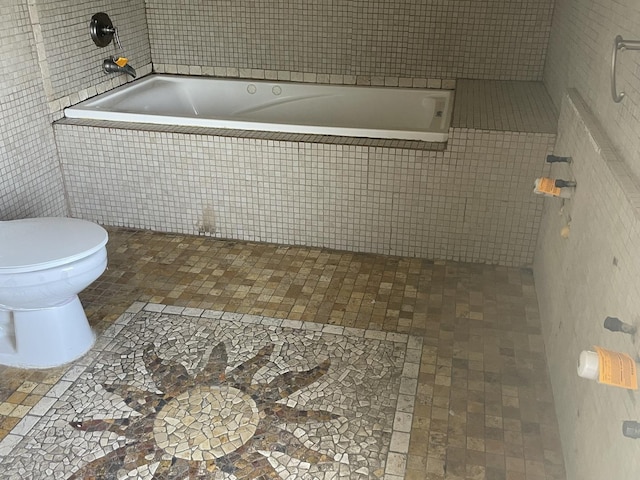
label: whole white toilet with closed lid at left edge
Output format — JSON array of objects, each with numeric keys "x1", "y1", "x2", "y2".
[{"x1": 0, "y1": 217, "x2": 109, "y2": 368}]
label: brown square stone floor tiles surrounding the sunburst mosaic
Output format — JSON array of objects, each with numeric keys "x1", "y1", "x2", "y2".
[{"x1": 0, "y1": 229, "x2": 564, "y2": 480}]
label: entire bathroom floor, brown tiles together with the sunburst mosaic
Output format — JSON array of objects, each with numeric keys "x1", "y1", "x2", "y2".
[{"x1": 0, "y1": 229, "x2": 565, "y2": 480}]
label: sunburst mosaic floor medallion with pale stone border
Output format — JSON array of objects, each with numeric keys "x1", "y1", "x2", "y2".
[{"x1": 0, "y1": 303, "x2": 421, "y2": 480}]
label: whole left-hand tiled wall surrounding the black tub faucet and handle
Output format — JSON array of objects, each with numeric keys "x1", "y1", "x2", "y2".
[{"x1": 0, "y1": 0, "x2": 151, "y2": 218}]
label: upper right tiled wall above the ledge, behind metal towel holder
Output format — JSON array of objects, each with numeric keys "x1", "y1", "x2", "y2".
[{"x1": 544, "y1": 0, "x2": 640, "y2": 182}]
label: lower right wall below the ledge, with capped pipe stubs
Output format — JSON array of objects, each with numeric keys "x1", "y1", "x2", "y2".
[{"x1": 535, "y1": 90, "x2": 640, "y2": 480}]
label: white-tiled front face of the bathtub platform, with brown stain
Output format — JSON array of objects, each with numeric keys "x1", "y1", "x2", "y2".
[{"x1": 55, "y1": 124, "x2": 554, "y2": 265}]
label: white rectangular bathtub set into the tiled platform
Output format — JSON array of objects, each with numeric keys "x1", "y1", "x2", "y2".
[{"x1": 65, "y1": 74, "x2": 453, "y2": 142}]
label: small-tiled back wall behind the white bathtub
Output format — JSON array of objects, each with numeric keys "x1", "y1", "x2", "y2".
[{"x1": 146, "y1": 0, "x2": 553, "y2": 80}]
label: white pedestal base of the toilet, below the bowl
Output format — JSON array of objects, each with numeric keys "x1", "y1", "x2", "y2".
[{"x1": 0, "y1": 295, "x2": 95, "y2": 368}]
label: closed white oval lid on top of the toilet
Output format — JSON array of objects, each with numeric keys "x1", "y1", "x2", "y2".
[{"x1": 0, "y1": 217, "x2": 109, "y2": 273}]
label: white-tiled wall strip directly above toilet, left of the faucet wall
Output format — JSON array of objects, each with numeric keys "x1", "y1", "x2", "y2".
[{"x1": 0, "y1": 1, "x2": 66, "y2": 220}]
